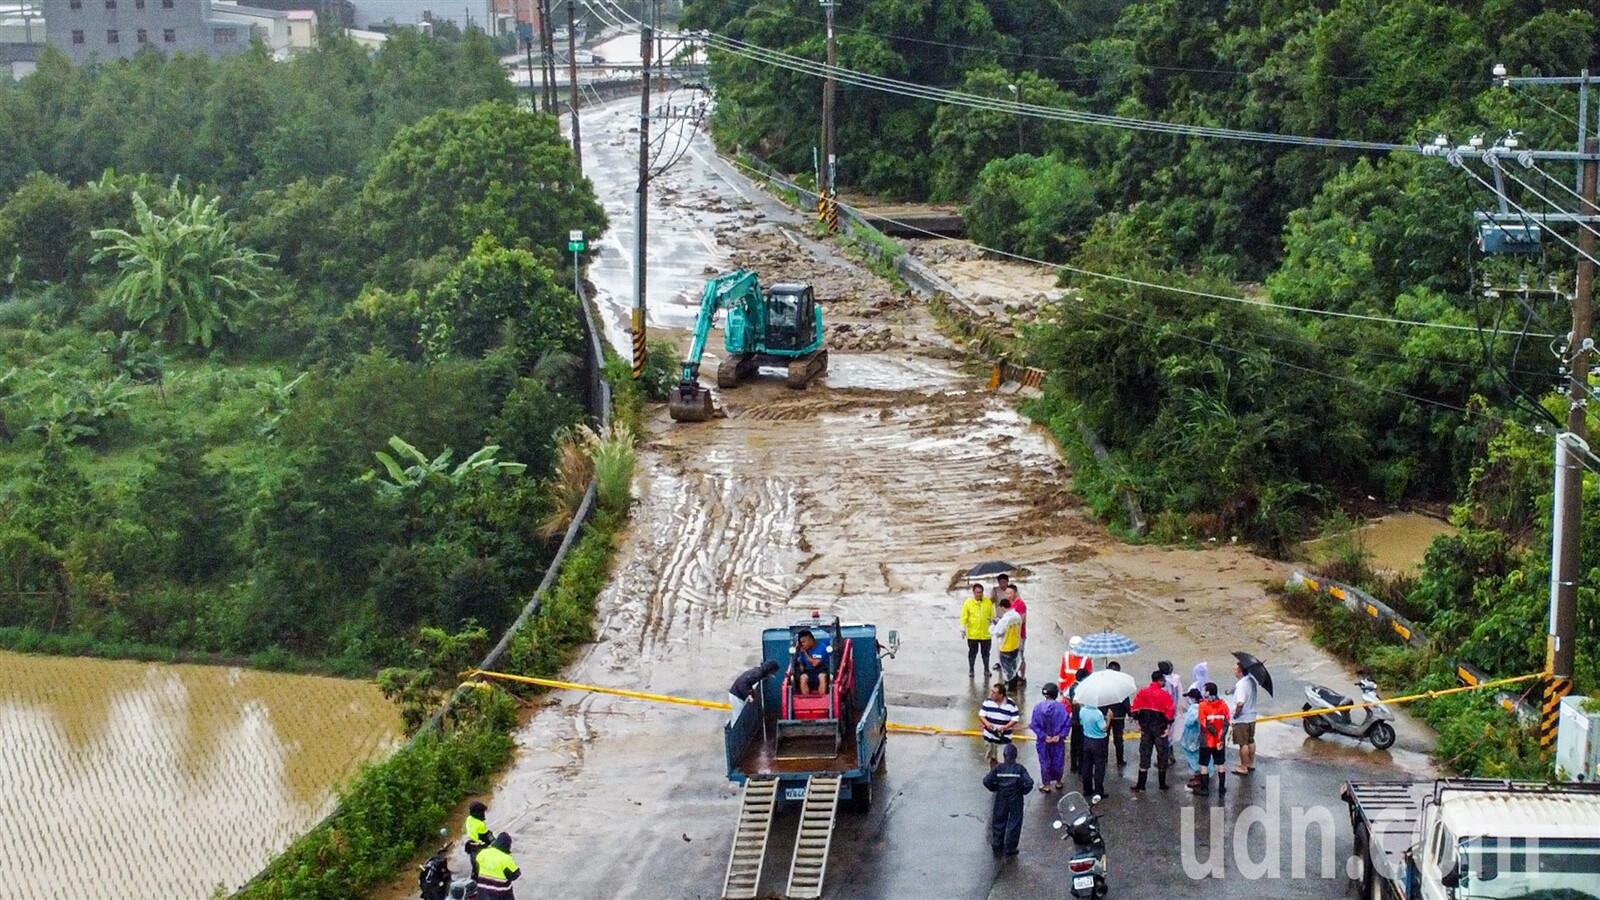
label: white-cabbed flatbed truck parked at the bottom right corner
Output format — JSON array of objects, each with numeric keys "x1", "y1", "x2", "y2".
[{"x1": 1341, "y1": 778, "x2": 1600, "y2": 900}]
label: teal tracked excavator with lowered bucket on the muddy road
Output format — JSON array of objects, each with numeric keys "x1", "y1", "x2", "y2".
[{"x1": 667, "y1": 269, "x2": 827, "y2": 421}]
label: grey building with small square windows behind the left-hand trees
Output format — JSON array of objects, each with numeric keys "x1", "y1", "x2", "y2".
[{"x1": 38, "y1": 0, "x2": 254, "y2": 64}]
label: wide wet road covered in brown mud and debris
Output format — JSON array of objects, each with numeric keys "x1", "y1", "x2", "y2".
[{"x1": 412, "y1": 104, "x2": 1427, "y2": 897}]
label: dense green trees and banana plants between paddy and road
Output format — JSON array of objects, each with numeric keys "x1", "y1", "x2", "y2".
[{"x1": 0, "y1": 32, "x2": 605, "y2": 669}]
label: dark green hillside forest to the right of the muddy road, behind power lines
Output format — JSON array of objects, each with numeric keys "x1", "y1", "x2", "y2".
[{"x1": 685, "y1": 0, "x2": 1600, "y2": 720}]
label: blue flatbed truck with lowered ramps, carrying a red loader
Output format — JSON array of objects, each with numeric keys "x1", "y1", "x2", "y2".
[{"x1": 723, "y1": 613, "x2": 899, "y2": 900}]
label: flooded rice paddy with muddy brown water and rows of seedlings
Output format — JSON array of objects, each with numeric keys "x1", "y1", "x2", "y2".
[{"x1": 0, "y1": 653, "x2": 400, "y2": 900}]
